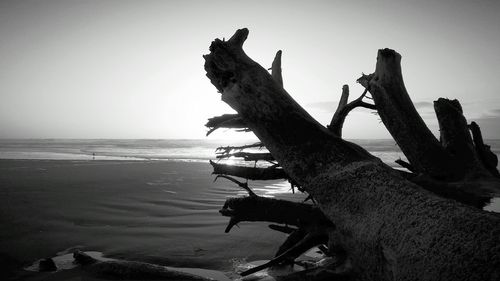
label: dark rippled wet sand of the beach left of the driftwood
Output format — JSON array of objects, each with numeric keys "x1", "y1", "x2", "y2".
[{"x1": 0, "y1": 160, "x2": 298, "y2": 280}]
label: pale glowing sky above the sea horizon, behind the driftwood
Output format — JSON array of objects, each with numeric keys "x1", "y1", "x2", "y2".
[{"x1": 0, "y1": 0, "x2": 500, "y2": 139}]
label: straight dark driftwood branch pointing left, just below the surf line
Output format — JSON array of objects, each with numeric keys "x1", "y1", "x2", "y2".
[{"x1": 210, "y1": 161, "x2": 288, "y2": 180}]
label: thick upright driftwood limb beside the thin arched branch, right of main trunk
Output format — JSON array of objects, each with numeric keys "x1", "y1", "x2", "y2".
[{"x1": 358, "y1": 49, "x2": 465, "y2": 179}]
